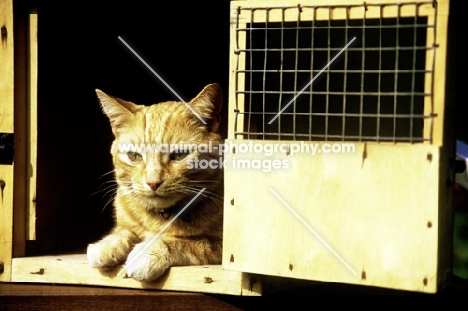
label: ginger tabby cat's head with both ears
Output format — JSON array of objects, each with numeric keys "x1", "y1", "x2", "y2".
[{"x1": 96, "y1": 84, "x2": 222, "y2": 209}]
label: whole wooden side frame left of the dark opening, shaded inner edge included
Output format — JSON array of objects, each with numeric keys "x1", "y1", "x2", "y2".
[{"x1": 0, "y1": 1, "x2": 37, "y2": 281}]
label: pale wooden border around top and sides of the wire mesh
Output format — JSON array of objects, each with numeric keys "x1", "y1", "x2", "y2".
[{"x1": 228, "y1": 0, "x2": 449, "y2": 146}]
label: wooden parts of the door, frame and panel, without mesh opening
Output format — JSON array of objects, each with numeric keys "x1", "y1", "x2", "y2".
[{"x1": 223, "y1": 0, "x2": 453, "y2": 293}]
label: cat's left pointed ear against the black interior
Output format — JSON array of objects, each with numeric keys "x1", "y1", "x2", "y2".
[{"x1": 96, "y1": 89, "x2": 139, "y2": 134}]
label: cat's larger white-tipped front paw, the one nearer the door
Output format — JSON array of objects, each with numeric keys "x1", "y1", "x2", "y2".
[{"x1": 125, "y1": 241, "x2": 171, "y2": 282}]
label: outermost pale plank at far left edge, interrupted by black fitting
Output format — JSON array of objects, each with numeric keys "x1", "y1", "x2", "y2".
[{"x1": 0, "y1": 0, "x2": 14, "y2": 281}]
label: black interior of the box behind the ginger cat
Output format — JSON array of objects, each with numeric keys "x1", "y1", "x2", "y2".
[{"x1": 27, "y1": 0, "x2": 229, "y2": 255}]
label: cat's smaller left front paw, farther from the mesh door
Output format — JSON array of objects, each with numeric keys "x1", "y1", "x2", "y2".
[{"x1": 86, "y1": 240, "x2": 127, "y2": 268}]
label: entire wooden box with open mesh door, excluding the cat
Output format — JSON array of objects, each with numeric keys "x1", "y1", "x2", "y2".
[{"x1": 0, "y1": 0, "x2": 452, "y2": 295}]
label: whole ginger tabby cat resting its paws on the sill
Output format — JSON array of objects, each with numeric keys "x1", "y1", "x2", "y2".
[{"x1": 87, "y1": 84, "x2": 223, "y2": 281}]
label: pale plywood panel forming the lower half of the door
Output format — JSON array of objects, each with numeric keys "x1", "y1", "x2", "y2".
[{"x1": 223, "y1": 140, "x2": 450, "y2": 292}]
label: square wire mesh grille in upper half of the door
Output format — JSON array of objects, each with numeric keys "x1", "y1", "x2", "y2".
[{"x1": 234, "y1": 2, "x2": 436, "y2": 142}]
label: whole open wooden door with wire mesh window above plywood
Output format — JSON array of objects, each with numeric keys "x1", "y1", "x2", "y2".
[{"x1": 223, "y1": 0, "x2": 453, "y2": 293}]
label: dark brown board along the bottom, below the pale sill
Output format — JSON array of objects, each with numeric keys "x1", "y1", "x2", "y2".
[{"x1": 0, "y1": 283, "x2": 245, "y2": 311}]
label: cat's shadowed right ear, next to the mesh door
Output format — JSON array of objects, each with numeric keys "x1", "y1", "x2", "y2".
[{"x1": 189, "y1": 83, "x2": 223, "y2": 132}]
